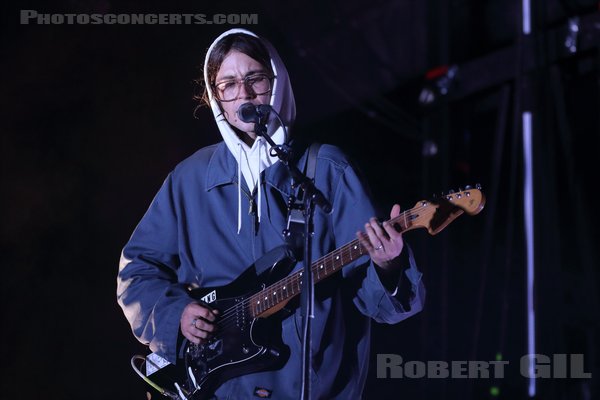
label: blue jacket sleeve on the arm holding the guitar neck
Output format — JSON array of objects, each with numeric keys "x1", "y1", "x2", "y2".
[{"x1": 332, "y1": 165, "x2": 425, "y2": 324}]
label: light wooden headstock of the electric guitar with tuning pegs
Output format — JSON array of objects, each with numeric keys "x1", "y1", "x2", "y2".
[{"x1": 393, "y1": 185, "x2": 485, "y2": 235}]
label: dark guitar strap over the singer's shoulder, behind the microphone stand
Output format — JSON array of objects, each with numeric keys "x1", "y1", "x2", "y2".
[{"x1": 283, "y1": 142, "x2": 321, "y2": 261}]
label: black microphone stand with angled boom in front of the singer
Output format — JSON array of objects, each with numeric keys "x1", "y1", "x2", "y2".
[{"x1": 254, "y1": 114, "x2": 332, "y2": 400}]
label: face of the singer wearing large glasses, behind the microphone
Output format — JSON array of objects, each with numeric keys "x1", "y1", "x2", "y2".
[{"x1": 215, "y1": 50, "x2": 271, "y2": 139}]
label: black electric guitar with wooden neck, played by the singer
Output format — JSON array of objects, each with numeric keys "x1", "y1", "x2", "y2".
[{"x1": 132, "y1": 185, "x2": 485, "y2": 400}]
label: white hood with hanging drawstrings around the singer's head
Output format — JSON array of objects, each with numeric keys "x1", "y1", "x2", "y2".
[{"x1": 204, "y1": 29, "x2": 296, "y2": 232}]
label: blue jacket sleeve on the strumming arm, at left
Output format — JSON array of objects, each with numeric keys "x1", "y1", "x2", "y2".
[{"x1": 117, "y1": 175, "x2": 192, "y2": 363}]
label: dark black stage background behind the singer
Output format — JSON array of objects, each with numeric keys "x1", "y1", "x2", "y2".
[{"x1": 0, "y1": 0, "x2": 600, "y2": 399}]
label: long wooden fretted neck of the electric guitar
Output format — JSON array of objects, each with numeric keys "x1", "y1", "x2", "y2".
[{"x1": 248, "y1": 207, "x2": 416, "y2": 318}]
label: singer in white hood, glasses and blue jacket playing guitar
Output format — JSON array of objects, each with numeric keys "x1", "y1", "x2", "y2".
[{"x1": 117, "y1": 29, "x2": 425, "y2": 399}]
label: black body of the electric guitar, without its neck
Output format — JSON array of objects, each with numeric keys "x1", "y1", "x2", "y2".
[{"x1": 148, "y1": 248, "x2": 295, "y2": 400}]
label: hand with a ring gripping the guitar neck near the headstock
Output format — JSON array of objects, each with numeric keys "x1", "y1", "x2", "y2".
[{"x1": 356, "y1": 204, "x2": 404, "y2": 270}]
